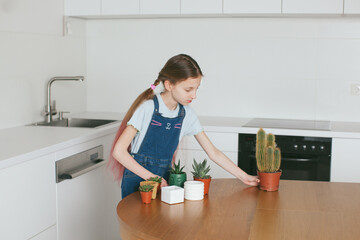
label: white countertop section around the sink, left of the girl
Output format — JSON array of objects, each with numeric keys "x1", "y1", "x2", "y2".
[{"x1": 0, "y1": 112, "x2": 123, "y2": 169}]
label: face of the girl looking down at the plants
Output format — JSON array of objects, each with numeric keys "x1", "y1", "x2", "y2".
[{"x1": 167, "y1": 76, "x2": 201, "y2": 106}]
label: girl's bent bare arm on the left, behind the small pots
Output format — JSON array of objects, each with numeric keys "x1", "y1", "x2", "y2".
[{"x1": 112, "y1": 125, "x2": 167, "y2": 187}]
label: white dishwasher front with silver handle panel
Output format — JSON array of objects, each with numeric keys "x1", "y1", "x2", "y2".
[{"x1": 56, "y1": 146, "x2": 107, "y2": 240}]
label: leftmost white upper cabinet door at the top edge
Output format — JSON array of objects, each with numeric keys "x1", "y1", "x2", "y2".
[{"x1": 64, "y1": 0, "x2": 101, "y2": 16}]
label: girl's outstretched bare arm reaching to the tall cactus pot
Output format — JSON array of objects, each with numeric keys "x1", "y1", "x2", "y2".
[{"x1": 195, "y1": 131, "x2": 259, "y2": 186}]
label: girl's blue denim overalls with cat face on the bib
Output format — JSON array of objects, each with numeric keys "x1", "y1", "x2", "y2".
[{"x1": 121, "y1": 95, "x2": 185, "y2": 198}]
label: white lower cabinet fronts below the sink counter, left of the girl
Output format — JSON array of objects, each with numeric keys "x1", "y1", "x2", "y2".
[{"x1": 0, "y1": 133, "x2": 121, "y2": 240}]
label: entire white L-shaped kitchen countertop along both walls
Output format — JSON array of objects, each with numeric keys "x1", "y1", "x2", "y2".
[{"x1": 0, "y1": 112, "x2": 360, "y2": 169}]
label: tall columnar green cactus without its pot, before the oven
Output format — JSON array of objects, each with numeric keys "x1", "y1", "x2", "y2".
[{"x1": 256, "y1": 128, "x2": 281, "y2": 173}]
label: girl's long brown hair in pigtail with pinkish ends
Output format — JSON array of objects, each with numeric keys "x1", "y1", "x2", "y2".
[{"x1": 108, "y1": 54, "x2": 203, "y2": 181}]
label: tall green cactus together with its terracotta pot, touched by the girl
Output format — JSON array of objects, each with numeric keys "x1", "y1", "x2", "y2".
[{"x1": 256, "y1": 128, "x2": 281, "y2": 191}]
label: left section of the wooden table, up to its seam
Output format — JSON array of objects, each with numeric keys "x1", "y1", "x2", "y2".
[{"x1": 117, "y1": 179, "x2": 259, "y2": 240}]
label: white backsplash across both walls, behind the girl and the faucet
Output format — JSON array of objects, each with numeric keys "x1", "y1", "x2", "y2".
[{"x1": 0, "y1": 12, "x2": 360, "y2": 129}]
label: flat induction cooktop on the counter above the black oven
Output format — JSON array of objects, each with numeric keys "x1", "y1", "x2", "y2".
[{"x1": 243, "y1": 118, "x2": 330, "y2": 131}]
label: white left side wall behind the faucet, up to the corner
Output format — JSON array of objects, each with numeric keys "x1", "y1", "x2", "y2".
[{"x1": 0, "y1": 0, "x2": 86, "y2": 129}]
